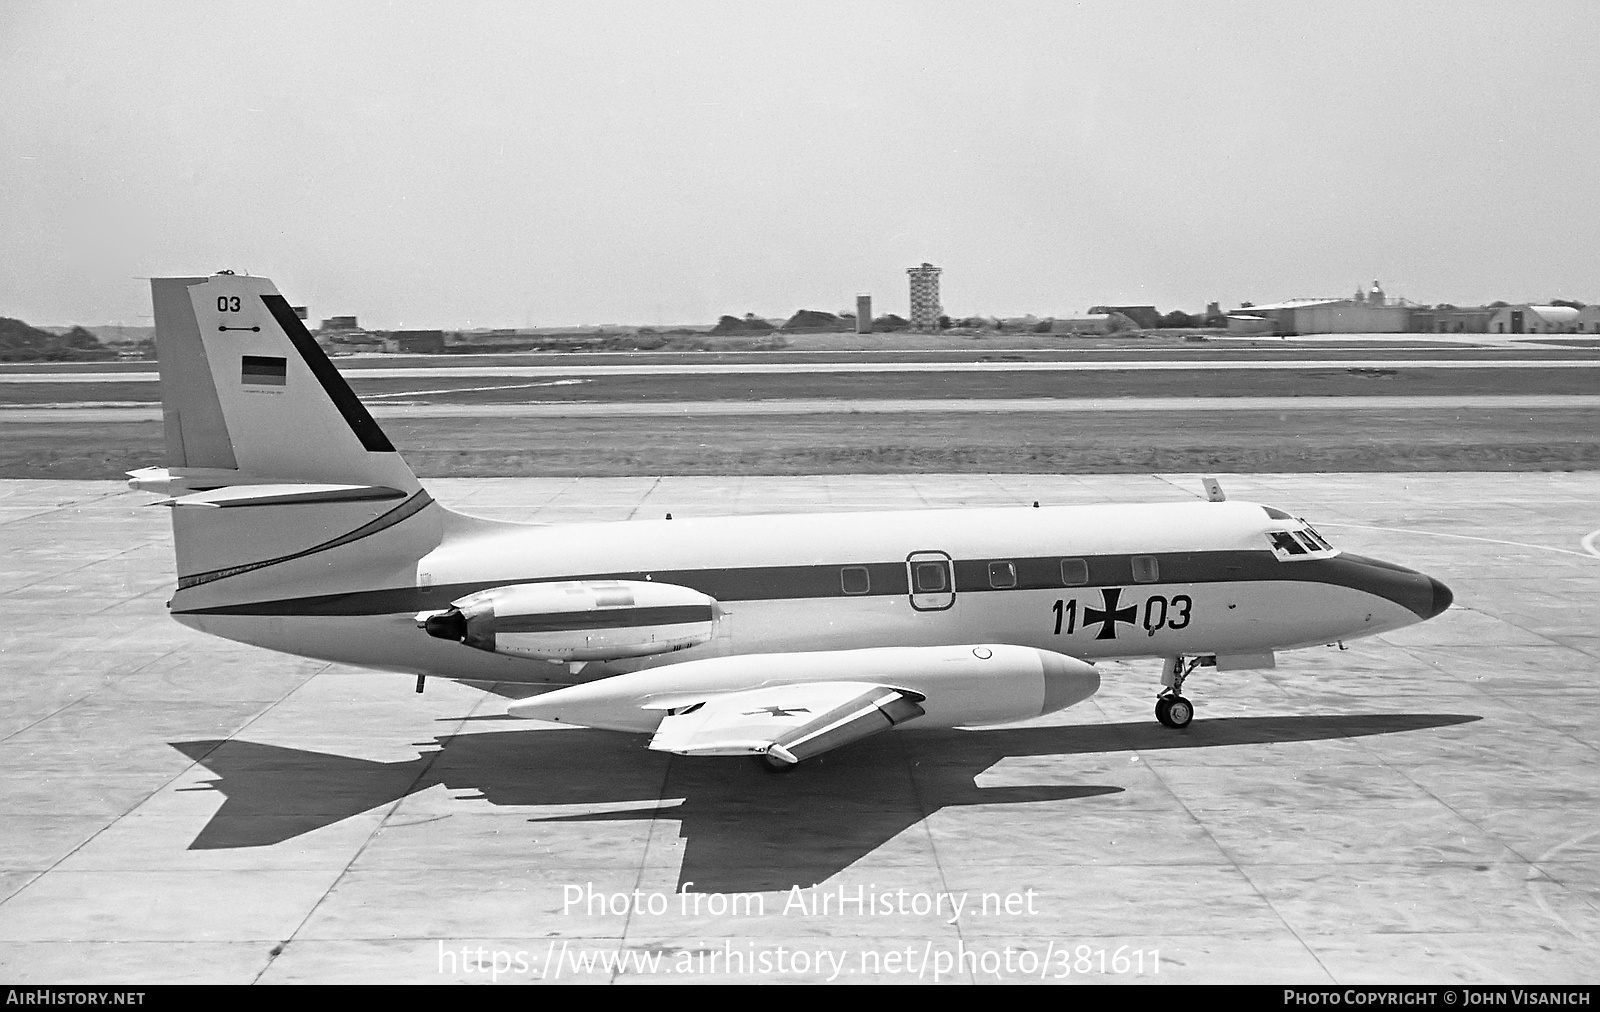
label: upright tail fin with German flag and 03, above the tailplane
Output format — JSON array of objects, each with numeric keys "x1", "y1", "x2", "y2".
[{"x1": 141, "y1": 274, "x2": 421, "y2": 493}]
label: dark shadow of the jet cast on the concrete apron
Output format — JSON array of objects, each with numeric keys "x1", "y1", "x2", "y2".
[{"x1": 173, "y1": 714, "x2": 1478, "y2": 892}]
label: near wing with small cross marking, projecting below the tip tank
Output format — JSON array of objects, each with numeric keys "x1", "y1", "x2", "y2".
[{"x1": 650, "y1": 682, "x2": 925, "y2": 764}]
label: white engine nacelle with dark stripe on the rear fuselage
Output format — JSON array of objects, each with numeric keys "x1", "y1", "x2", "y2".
[{"x1": 418, "y1": 580, "x2": 718, "y2": 661}]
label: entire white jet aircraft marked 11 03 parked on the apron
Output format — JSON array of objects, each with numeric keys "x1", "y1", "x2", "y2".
[{"x1": 130, "y1": 272, "x2": 1451, "y2": 769}]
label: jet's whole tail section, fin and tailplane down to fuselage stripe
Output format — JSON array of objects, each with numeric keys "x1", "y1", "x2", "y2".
[{"x1": 140, "y1": 274, "x2": 445, "y2": 613}]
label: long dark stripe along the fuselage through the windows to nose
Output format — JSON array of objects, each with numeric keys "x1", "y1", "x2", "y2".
[{"x1": 174, "y1": 551, "x2": 1432, "y2": 616}]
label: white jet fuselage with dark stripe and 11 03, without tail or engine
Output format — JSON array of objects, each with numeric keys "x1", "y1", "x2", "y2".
[{"x1": 174, "y1": 501, "x2": 1448, "y2": 682}]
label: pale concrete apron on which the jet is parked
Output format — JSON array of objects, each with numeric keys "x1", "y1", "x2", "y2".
[{"x1": 0, "y1": 472, "x2": 1600, "y2": 985}]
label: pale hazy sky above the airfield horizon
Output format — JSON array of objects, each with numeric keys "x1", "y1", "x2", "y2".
[{"x1": 0, "y1": 0, "x2": 1600, "y2": 327}]
